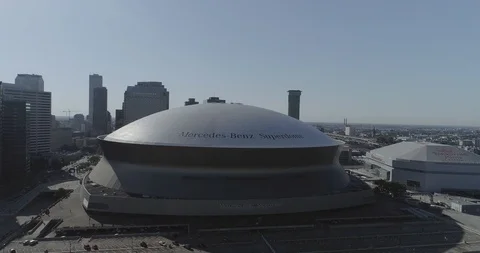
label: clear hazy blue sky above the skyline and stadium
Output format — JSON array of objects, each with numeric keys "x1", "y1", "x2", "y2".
[{"x1": 0, "y1": 0, "x2": 480, "y2": 126}]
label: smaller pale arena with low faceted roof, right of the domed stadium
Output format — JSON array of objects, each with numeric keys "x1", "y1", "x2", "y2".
[{"x1": 365, "y1": 142, "x2": 480, "y2": 192}]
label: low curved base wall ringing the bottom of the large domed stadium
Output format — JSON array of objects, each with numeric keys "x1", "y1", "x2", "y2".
[{"x1": 81, "y1": 184, "x2": 374, "y2": 216}]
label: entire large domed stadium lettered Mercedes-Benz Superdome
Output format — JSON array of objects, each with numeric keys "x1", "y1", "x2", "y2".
[{"x1": 81, "y1": 104, "x2": 373, "y2": 216}]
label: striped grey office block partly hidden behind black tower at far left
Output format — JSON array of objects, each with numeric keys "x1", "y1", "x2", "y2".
[{"x1": 1, "y1": 82, "x2": 52, "y2": 155}]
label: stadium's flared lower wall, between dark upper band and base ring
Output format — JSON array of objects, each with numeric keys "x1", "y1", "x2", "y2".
[{"x1": 89, "y1": 158, "x2": 350, "y2": 199}]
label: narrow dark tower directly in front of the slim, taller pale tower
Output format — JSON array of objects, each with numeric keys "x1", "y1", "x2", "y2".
[{"x1": 92, "y1": 87, "x2": 108, "y2": 135}]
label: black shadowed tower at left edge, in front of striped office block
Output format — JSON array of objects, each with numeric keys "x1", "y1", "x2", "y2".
[{"x1": 1, "y1": 99, "x2": 30, "y2": 180}]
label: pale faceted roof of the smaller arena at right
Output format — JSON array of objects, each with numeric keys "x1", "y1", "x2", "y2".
[{"x1": 370, "y1": 142, "x2": 480, "y2": 164}]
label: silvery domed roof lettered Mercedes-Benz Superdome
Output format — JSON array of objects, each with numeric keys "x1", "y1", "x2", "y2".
[{"x1": 104, "y1": 104, "x2": 339, "y2": 148}]
